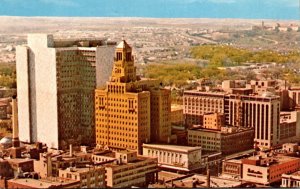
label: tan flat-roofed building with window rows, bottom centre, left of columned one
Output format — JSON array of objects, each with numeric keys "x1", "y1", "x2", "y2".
[{"x1": 92, "y1": 150, "x2": 158, "y2": 188}]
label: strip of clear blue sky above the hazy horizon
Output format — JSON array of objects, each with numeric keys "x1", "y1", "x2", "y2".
[{"x1": 0, "y1": 0, "x2": 300, "y2": 20}]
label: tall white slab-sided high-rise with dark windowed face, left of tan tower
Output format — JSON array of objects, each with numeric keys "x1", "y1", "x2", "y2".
[{"x1": 16, "y1": 34, "x2": 115, "y2": 149}]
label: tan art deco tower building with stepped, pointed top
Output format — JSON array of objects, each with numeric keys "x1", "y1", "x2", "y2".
[{"x1": 95, "y1": 41, "x2": 171, "y2": 153}]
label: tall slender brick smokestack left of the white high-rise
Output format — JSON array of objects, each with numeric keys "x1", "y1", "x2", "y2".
[{"x1": 12, "y1": 96, "x2": 20, "y2": 147}]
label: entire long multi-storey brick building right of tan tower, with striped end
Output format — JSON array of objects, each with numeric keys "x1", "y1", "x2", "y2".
[{"x1": 184, "y1": 91, "x2": 280, "y2": 148}]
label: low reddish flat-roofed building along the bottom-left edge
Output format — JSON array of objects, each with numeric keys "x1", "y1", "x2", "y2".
[{"x1": 7, "y1": 178, "x2": 80, "y2": 188}]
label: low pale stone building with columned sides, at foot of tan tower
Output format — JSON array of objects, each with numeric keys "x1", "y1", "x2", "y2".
[{"x1": 143, "y1": 144, "x2": 202, "y2": 172}]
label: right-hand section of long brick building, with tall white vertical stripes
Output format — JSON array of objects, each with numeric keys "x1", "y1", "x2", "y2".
[{"x1": 224, "y1": 92, "x2": 280, "y2": 148}]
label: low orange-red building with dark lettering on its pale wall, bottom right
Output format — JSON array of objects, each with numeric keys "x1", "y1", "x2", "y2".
[{"x1": 242, "y1": 152, "x2": 300, "y2": 185}]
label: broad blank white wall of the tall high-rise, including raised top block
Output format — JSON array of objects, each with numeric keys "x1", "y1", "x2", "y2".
[{"x1": 28, "y1": 34, "x2": 58, "y2": 148}]
